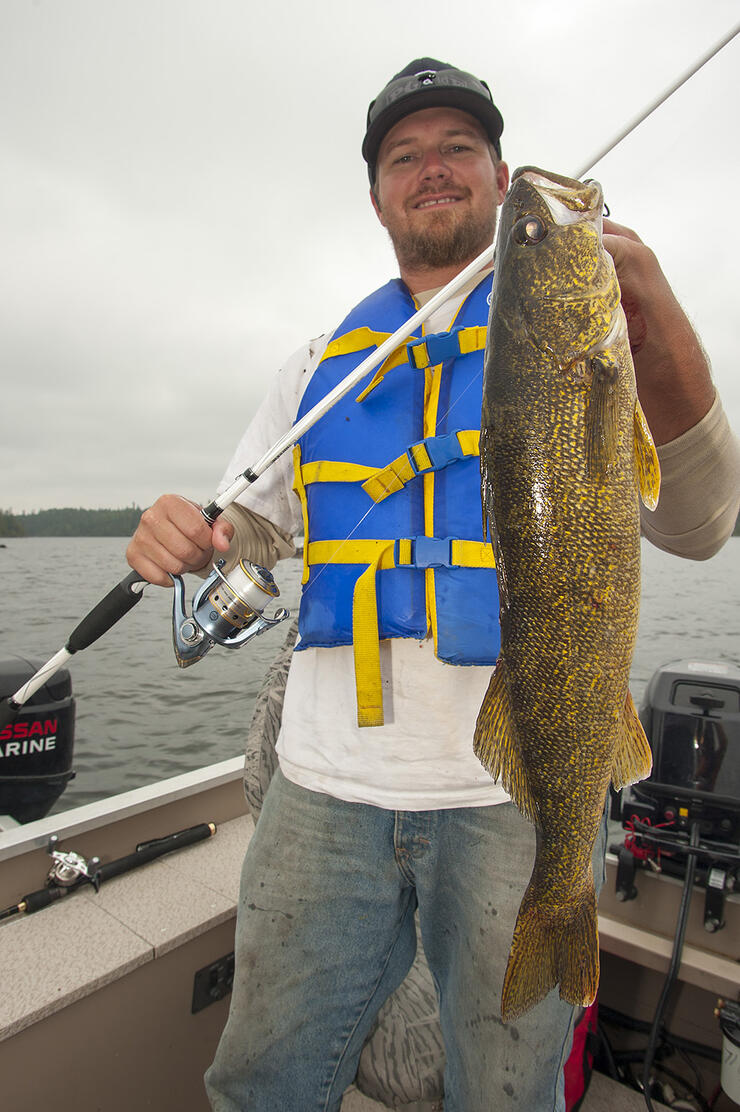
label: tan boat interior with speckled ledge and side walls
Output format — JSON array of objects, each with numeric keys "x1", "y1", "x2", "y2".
[{"x1": 0, "y1": 761, "x2": 740, "y2": 1112}]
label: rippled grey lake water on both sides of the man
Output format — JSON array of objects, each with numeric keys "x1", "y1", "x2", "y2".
[{"x1": 0, "y1": 537, "x2": 740, "y2": 812}]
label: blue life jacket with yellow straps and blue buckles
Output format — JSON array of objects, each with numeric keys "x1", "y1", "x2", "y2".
[{"x1": 294, "y1": 275, "x2": 501, "y2": 725}]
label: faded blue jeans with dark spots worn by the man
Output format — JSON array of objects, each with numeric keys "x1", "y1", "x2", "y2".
[{"x1": 206, "y1": 770, "x2": 604, "y2": 1112}]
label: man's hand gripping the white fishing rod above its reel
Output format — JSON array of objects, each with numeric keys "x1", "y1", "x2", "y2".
[{"x1": 126, "y1": 494, "x2": 234, "y2": 587}]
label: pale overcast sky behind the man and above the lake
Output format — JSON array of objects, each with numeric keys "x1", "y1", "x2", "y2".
[{"x1": 0, "y1": 0, "x2": 740, "y2": 513}]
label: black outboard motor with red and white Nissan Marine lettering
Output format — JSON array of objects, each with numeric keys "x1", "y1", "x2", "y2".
[{"x1": 0, "y1": 656, "x2": 75, "y2": 823}]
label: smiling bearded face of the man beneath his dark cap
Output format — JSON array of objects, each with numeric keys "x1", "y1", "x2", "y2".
[{"x1": 371, "y1": 108, "x2": 509, "y2": 272}]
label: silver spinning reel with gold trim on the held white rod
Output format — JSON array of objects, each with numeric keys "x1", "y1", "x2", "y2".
[{"x1": 170, "y1": 559, "x2": 290, "y2": 668}]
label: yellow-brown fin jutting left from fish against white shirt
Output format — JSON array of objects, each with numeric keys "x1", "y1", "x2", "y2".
[{"x1": 473, "y1": 657, "x2": 537, "y2": 823}]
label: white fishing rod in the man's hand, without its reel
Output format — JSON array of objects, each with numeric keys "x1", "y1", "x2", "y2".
[{"x1": 0, "y1": 24, "x2": 740, "y2": 729}]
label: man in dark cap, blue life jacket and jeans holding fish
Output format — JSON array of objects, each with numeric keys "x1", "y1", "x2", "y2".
[{"x1": 128, "y1": 59, "x2": 740, "y2": 1112}]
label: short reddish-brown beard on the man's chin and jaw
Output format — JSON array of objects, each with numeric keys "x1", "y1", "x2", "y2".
[{"x1": 386, "y1": 195, "x2": 497, "y2": 270}]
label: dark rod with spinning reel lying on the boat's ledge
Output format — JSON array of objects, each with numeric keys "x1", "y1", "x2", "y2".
[{"x1": 0, "y1": 823, "x2": 216, "y2": 920}]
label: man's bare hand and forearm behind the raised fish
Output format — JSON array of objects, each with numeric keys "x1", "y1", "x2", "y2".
[{"x1": 604, "y1": 220, "x2": 714, "y2": 444}]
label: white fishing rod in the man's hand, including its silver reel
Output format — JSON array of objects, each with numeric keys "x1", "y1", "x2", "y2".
[{"x1": 0, "y1": 23, "x2": 740, "y2": 729}]
